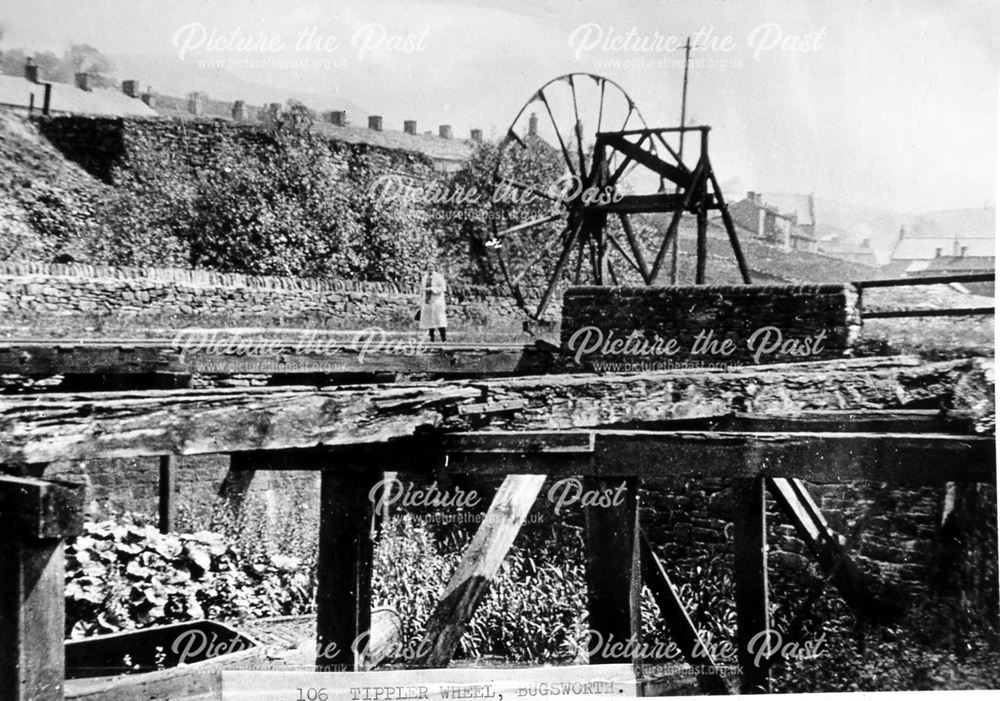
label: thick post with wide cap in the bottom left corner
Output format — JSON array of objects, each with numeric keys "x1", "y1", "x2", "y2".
[{"x1": 0, "y1": 476, "x2": 83, "y2": 701}]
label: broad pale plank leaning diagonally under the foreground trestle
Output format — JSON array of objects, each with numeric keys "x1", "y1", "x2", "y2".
[{"x1": 415, "y1": 475, "x2": 545, "y2": 667}]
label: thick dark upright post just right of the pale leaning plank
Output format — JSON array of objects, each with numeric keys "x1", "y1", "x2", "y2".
[{"x1": 583, "y1": 477, "x2": 642, "y2": 664}]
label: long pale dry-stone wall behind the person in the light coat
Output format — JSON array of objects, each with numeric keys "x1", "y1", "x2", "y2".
[{"x1": 0, "y1": 262, "x2": 558, "y2": 336}]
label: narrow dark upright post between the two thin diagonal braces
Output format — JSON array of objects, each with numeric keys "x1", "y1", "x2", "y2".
[{"x1": 733, "y1": 477, "x2": 771, "y2": 694}]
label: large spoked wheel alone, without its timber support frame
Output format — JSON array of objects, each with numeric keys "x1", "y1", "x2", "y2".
[{"x1": 487, "y1": 73, "x2": 666, "y2": 319}]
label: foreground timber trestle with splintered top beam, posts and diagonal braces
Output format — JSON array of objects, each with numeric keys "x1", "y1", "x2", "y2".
[{"x1": 0, "y1": 359, "x2": 996, "y2": 699}]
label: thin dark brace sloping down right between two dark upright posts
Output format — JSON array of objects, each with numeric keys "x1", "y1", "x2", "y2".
[{"x1": 640, "y1": 532, "x2": 729, "y2": 694}]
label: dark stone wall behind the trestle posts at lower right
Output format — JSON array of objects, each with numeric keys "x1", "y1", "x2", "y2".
[{"x1": 642, "y1": 478, "x2": 997, "y2": 603}]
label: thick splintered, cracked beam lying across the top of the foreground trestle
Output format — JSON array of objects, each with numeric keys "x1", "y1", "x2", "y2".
[{"x1": 0, "y1": 359, "x2": 992, "y2": 464}]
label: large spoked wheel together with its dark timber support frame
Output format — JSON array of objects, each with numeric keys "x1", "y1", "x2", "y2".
[{"x1": 492, "y1": 73, "x2": 751, "y2": 319}]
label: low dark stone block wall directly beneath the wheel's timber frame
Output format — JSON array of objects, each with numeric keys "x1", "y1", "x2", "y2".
[{"x1": 561, "y1": 284, "x2": 861, "y2": 369}]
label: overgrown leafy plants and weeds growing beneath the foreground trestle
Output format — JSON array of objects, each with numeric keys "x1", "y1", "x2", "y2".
[{"x1": 66, "y1": 498, "x2": 1000, "y2": 692}]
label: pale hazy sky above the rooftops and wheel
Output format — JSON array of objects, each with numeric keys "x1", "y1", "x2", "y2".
[{"x1": 0, "y1": 0, "x2": 1000, "y2": 213}]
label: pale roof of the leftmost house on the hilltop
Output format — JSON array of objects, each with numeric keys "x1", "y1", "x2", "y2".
[{"x1": 0, "y1": 75, "x2": 156, "y2": 117}]
